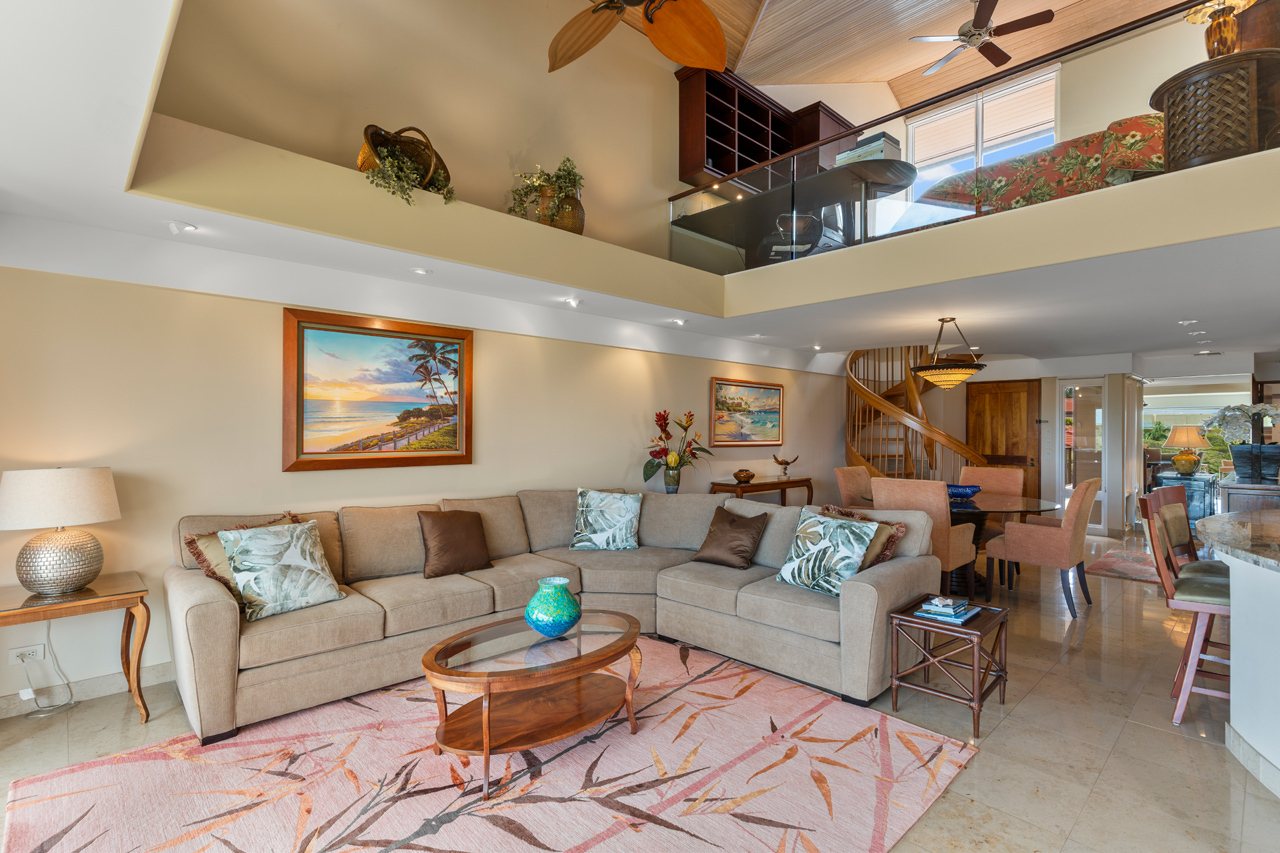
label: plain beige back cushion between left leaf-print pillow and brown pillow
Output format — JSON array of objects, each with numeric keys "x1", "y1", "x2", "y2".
[{"x1": 338, "y1": 503, "x2": 440, "y2": 583}]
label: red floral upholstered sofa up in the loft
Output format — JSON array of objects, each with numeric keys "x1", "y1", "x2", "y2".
[{"x1": 916, "y1": 113, "x2": 1165, "y2": 216}]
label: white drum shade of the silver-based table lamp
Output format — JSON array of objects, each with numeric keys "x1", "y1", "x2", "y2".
[{"x1": 0, "y1": 467, "x2": 120, "y2": 530}]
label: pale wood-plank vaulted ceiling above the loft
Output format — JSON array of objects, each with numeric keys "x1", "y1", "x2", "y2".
[{"x1": 609, "y1": 0, "x2": 1187, "y2": 106}]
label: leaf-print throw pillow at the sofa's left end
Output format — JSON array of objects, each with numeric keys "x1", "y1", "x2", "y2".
[{"x1": 218, "y1": 520, "x2": 346, "y2": 622}]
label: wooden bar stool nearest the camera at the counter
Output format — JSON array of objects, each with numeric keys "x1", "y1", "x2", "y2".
[{"x1": 1138, "y1": 496, "x2": 1231, "y2": 725}]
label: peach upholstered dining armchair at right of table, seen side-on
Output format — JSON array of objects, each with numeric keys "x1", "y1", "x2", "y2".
[{"x1": 987, "y1": 479, "x2": 1102, "y2": 619}]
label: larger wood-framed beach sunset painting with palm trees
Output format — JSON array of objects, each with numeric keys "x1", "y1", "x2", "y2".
[{"x1": 284, "y1": 309, "x2": 472, "y2": 471}]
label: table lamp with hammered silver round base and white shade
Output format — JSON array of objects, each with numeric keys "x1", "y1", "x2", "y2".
[{"x1": 0, "y1": 467, "x2": 120, "y2": 596}]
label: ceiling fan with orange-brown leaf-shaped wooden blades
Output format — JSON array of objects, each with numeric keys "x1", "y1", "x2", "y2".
[{"x1": 547, "y1": 0, "x2": 728, "y2": 72}]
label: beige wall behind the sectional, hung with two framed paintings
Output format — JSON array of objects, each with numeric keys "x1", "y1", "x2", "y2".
[{"x1": 0, "y1": 268, "x2": 844, "y2": 695}]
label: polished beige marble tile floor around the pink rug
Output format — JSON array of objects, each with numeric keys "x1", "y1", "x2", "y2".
[{"x1": 0, "y1": 527, "x2": 1280, "y2": 853}]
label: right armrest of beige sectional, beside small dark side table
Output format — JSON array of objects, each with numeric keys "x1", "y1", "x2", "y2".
[{"x1": 840, "y1": 556, "x2": 942, "y2": 702}]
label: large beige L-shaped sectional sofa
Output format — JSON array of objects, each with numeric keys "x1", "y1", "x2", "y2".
[{"x1": 164, "y1": 489, "x2": 940, "y2": 743}]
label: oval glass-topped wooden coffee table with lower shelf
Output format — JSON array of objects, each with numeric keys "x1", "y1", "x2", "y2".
[{"x1": 422, "y1": 610, "x2": 640, "y2": 799}]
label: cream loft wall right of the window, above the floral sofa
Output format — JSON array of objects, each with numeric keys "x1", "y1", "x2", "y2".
[{"x1": 1059, "y1": 18, "x2": 1206, "y2": 140}]
